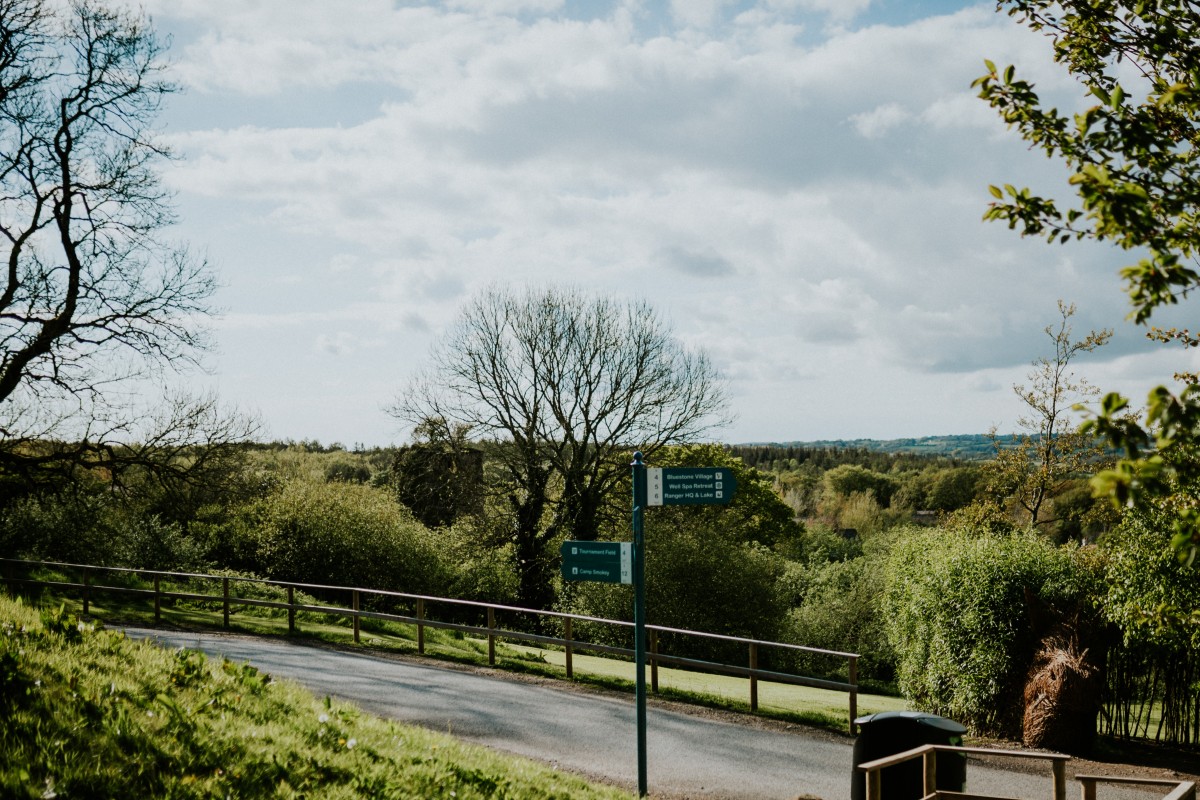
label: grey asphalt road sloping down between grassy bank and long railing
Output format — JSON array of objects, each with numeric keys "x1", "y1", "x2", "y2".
[{"x1": 125, "y1": 628, "x2": 1166, "y2": 800}]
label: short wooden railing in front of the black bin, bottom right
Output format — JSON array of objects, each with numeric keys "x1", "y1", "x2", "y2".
[{"x1": 858, "y1": 745, "x2": 1196, "y2": 800}]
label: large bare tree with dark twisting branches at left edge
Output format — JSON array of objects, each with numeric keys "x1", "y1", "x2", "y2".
[{"x1": 0, "y1": 0, "x2": 246, "y2": 489}]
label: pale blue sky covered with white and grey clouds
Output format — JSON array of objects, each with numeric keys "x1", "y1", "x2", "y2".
[{"x1": 136, "y1": 0, "x2": 1187, "y2": 445}]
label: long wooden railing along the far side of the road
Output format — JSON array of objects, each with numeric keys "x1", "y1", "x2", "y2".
[{"x1": 0, "y1": 559, "x2": 858, "y2": 734}]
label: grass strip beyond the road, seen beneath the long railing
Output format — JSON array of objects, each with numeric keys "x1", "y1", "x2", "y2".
[{"x1": 11, "y1": 573, "x2": 907, "y2": 733}]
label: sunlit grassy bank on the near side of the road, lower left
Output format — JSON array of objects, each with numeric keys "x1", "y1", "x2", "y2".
[{"x1": 0, "y1": 596, "x2": 629, "y2": 800}]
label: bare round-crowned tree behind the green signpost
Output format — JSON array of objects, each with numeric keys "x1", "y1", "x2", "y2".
[{"x1": 391, "y1": 288, "x2": 726, "y2": 607}]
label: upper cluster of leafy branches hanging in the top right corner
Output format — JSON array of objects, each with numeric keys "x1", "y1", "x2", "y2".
[{"x1": 974, "y1": 0, "x2": 1200, "y2": 321}]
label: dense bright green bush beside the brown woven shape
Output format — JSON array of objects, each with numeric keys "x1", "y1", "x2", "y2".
[{"x1": 883, "y1": 529, "x2": 1099, "y2": 736}]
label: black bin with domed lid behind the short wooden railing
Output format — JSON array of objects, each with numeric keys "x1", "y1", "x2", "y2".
[{"x1": 850, "y1": 711, "x2": 967, "y2": 800}]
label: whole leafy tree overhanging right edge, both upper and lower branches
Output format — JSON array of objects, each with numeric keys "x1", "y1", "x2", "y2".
[{"x1": 976, "y1": 0, "x2": 1200, "y2": 557}]
